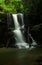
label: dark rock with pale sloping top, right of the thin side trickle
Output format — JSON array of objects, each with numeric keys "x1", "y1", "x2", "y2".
[{"x1": 31, "y1": 24, "x2": 42, "y2": 47}]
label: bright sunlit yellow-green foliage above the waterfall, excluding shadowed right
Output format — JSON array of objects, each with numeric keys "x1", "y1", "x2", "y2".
[{"x1": 2, "y1": 0, "x2": 23, "y2": 13}]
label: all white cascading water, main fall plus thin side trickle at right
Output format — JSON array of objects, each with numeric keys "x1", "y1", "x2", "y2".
[{"x1": 12, "y1": 13, "x2": 37, "y2": 49}]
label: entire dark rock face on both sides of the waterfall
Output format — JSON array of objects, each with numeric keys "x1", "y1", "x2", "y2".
[{"x1": 0, "y1": 13, "x2": 42, "y2": 47}]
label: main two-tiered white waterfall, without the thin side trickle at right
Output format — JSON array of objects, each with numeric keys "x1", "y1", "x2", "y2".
[{"x1": 12, "y1": 14, "x2": 29, "y2": 49}]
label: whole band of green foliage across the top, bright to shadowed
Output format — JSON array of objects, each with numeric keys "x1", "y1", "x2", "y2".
[{"x1": 0, "y1": 0, "x2": 42, "y2": 14}]
